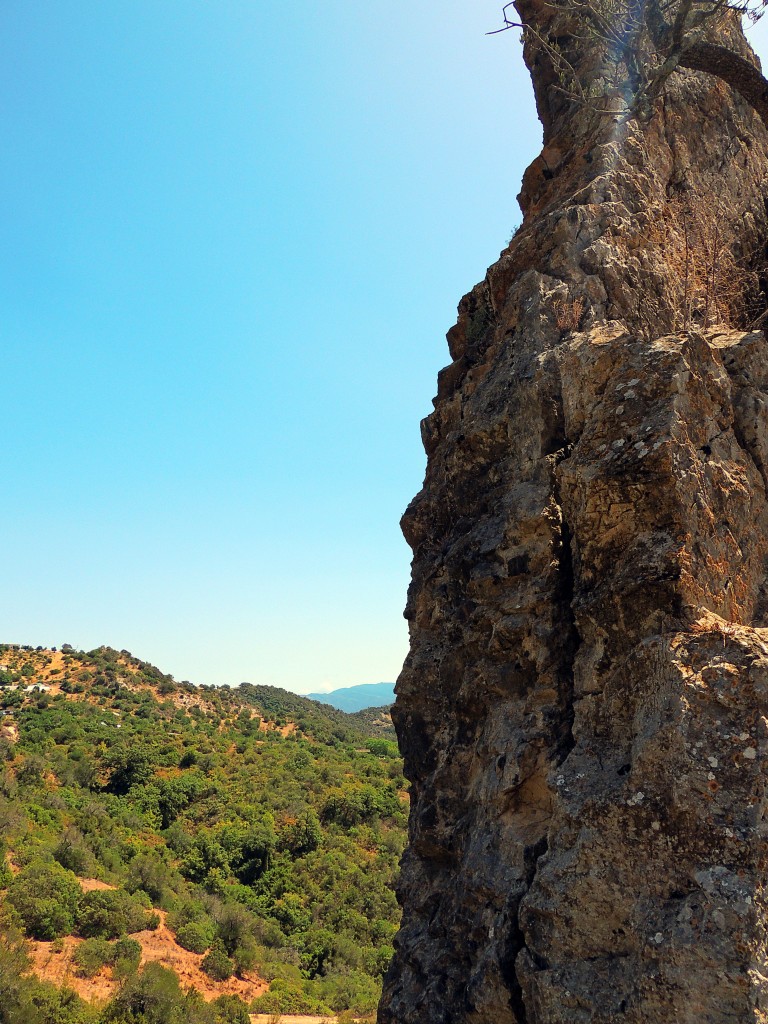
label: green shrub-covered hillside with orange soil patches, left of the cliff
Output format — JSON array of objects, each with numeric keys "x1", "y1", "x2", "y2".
[{"x1": 0, "y1": 645, "x2": 408, "y2": 1024}]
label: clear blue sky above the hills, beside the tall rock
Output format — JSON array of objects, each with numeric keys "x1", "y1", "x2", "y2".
[{"x1": 6, "y1": 0, "x2": 765, "y2": 691}]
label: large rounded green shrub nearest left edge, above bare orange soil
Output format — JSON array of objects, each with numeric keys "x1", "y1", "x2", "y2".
[{"x1": 8, "y1": 861, "x2": 82, "y2": 941}]
